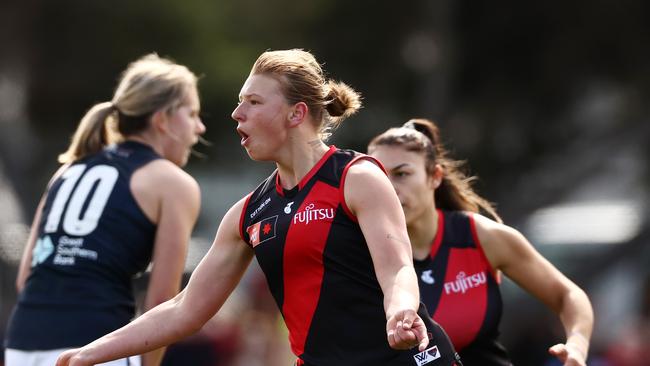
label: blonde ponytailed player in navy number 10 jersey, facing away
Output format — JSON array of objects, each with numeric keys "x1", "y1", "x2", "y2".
[{"x1": 5, "y1": 54, "x2": 205, "y2": 366}]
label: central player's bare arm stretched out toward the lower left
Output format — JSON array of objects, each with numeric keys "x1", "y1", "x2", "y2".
[{"x1": 57, "y1": 200, "x2": 253, "y2": 366}]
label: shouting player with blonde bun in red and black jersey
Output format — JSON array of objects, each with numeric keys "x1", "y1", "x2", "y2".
[{"x1": 58, "y1": 49, "x2": 456, "y2": 366}]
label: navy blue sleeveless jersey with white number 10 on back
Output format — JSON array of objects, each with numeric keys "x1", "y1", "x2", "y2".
[{"x1": 6, "y1": 141, "x2": 160, "y2": 350}]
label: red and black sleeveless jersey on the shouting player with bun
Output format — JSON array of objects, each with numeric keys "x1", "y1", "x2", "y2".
[{"x1": 240, "y1": 146, "x2": 456, "y2": 366}]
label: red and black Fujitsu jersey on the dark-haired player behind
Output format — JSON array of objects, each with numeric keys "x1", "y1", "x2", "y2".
[{"x1": 414, "y1": 210, "x2": 511, "y2": 366}]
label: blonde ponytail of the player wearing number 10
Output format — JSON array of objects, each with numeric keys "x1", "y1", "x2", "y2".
[{"x1": 58, "y1": 102, "x2": 119, "y2": 164}]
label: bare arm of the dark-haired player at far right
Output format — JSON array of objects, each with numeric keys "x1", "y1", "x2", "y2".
[{"x1": 474, "y1": 215, "x2": 594, "y2": 366}]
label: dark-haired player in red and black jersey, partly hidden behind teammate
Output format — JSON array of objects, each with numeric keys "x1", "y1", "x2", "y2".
[{"x1": 368, "y1": 119, "x2": 593, "y2": 366}]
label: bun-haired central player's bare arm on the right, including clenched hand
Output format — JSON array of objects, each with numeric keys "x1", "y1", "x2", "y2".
[{"x1": 344, "y1": 161, "x2": 429, "y2": 351}]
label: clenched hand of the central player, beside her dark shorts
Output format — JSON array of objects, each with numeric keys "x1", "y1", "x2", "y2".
[{"x1": 386, "y1": 309, "x2": 429, "y2": 351}]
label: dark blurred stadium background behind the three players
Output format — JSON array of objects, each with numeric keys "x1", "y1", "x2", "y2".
[{"x1": 0, "y1": 0, "x2": 650, "y2": 366}]
